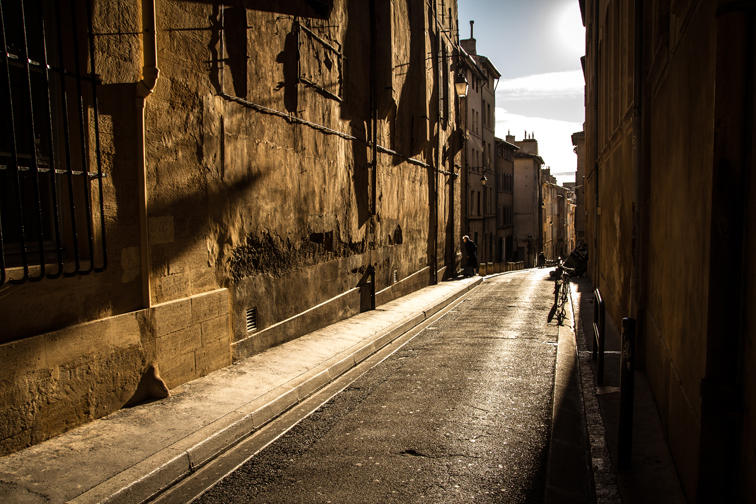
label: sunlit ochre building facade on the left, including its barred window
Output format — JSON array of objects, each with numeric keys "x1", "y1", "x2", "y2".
[{"x1": 0, "y1": 0, "x2": 462, "y2": 454}]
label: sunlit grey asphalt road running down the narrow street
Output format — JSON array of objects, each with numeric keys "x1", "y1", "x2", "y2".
[{"x1": 198, "y1": 270, "x2": 557, "y2": 504}]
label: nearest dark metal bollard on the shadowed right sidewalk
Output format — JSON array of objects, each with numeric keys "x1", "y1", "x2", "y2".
[{"x1": 617, "y1": 317, "x2": 635, "y2": 470}]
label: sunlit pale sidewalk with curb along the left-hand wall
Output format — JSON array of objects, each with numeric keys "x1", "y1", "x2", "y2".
[{"x1": 0, "y1": 277, "x2": 483, "y2": 504}]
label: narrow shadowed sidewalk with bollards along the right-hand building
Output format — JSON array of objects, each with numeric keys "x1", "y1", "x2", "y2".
[{"x1": 572, "y1": 278, "x2": 685, "y2": 504}]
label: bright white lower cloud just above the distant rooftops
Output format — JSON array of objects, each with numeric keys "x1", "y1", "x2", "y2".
[{"x1": 496, "y1": 107, "x2": 583, "y2": 184}]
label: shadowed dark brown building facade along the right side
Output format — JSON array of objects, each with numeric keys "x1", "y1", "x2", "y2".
[{"x1": 576, "y1": 0, "x2": 756, "y2": 502}]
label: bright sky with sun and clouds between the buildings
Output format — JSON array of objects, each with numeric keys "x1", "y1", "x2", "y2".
[{"x1": 457, "y1": 0, "x2": 585, "y2": 184}]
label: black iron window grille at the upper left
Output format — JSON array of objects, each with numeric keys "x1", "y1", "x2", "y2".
[{"x1": 0, "y1": 0, "x2": 107, "y2": 285}]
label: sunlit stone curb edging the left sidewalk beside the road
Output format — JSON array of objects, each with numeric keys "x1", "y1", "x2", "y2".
[{"x1": 69, "y1": 277, "x2": 484, "y2": 504}]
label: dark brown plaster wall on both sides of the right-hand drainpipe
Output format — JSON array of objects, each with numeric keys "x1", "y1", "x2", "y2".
[{"x1": 585, "y1": 2, "x2": 716, "y2": 499}]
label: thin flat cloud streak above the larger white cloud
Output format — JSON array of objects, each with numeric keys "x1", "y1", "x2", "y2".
[{"x1": 496, "y1": 70, "x2": 585, "y2": 103}]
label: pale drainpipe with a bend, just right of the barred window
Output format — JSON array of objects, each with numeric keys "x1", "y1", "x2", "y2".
[{"x1": 136, "y1": 0, "x2": 160, "y2": 308}]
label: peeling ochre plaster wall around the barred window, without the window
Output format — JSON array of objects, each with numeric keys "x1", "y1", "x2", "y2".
[{"x1": 0, "y1": 0, "x2": 461, "y2": 453}]
